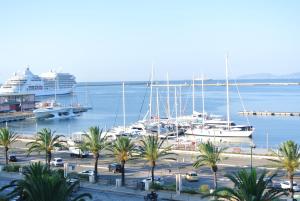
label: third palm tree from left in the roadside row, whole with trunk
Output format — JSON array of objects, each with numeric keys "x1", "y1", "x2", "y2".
[{"x1": 82, "y1": 126, "x2": 109, "y2": 181}]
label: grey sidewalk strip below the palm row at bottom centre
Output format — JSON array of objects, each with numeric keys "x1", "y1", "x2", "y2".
[{"x1": 81, "y1": 182, "x2": 208, "y2": 201}]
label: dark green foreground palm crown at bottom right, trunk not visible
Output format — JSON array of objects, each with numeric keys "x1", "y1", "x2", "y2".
[{"x1": 204, "y1": 169, "x2": 286, "y2": 201}]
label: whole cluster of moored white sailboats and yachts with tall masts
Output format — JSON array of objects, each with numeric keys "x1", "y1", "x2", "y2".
[{"x1": 107, "y1": 57, "x2": 254, "y2": 141}]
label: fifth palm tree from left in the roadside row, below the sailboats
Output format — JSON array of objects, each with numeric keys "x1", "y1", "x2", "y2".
[{"x1": 140, "y1": 135, "x2": 175, "y2": 184}]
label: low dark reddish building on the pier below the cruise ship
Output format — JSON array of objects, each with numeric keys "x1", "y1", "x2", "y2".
[{"x1": 0, "y1": 94, "x2": 35, "y2": 113}]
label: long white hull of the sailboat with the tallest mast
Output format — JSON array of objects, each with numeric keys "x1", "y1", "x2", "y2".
[{"x1": 186, "y1": 128, "x2": 254, "y2": 137}]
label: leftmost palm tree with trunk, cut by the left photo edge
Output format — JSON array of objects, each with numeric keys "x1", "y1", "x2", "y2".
[{"x1": 0, "y1": 128, "x2": 18, "y2": 165}]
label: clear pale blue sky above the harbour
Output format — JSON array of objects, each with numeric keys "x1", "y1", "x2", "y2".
[{"x1": 0, "y1": 0, "x2": 300, "y2": 82}]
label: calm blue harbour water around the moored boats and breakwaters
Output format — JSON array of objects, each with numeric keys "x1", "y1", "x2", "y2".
[{"x1": 2, "y1": 80, "x2": 300, "y2": 147}]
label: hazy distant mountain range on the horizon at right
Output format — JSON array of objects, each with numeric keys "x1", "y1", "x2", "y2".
[{"x1": 238, "y1": 72, "x2": 300, "y2": 79}]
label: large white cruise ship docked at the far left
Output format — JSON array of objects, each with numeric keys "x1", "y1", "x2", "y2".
[{"x1": 0, "y1": 68, "x2": 76, "y2": 96}]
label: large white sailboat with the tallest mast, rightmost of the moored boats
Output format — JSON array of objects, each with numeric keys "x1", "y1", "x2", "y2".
[{"x1": 186, "y1": 56, "x2": 254, "y2": 137}]
